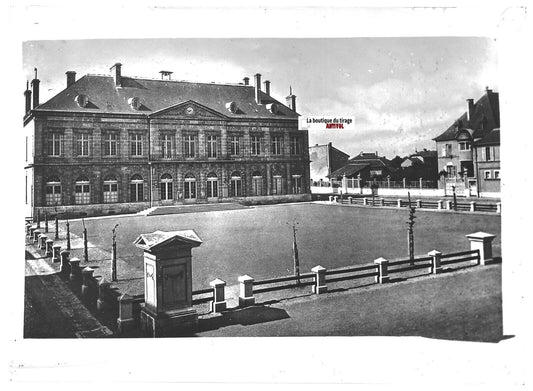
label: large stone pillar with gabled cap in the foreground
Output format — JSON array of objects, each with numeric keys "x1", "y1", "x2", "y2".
[{"x1": 134, "y1": 230, "x2": 202, "y2": 337}]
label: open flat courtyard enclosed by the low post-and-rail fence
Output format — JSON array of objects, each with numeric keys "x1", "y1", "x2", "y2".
[{"x1": 65, "y1": 203, "x2": 501, "y2": 289}]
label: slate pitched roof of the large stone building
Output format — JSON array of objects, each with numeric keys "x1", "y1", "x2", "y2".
[{"x1": 37, "y1": 75, "x2": 298, "y2": 119}]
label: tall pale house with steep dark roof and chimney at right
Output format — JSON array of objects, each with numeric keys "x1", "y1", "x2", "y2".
[{"x1": 433, "y1": 88, "x2": 500, "y2": 195}]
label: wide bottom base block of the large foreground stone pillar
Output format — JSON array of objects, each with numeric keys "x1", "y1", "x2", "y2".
[{"x1": 141, "y1": 307, "x2": 198, "y2": 338}]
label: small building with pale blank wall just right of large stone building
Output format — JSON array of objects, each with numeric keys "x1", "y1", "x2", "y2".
[{"x1": 309, "y1": 143, "x2": 350, "y2": 183}]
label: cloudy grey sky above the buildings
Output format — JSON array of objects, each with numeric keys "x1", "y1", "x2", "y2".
[{"x1": 21, "y1": 37, "x2": 498, "y2": 158}]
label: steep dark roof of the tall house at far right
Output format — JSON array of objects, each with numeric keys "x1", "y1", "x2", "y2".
[{"x1": 433, "y1": 90, "x2": 500, "y2": 141}]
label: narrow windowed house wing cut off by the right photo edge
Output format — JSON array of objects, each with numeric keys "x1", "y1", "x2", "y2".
[{"x1": 474, "y1": 128, "x2": 501, "y2": 197}]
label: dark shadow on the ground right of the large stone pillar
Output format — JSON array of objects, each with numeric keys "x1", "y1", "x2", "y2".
[{"x1": 198, "y1": 305, "x2": 290, "y2": 332}]
